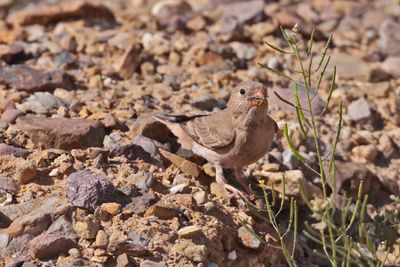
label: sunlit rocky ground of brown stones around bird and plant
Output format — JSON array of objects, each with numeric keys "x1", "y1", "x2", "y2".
[{"x1": 0, "y1": 0, "x2": 400, "y2": 267}]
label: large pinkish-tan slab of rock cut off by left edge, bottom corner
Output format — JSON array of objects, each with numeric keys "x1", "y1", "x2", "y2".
[{"x1": 0, "y1": 196, "x2": 72, "y2": 258}]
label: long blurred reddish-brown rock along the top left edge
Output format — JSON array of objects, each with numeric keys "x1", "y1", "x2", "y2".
[{"x1": 7, "y1": 0, "x2": 115, "y2": 25}]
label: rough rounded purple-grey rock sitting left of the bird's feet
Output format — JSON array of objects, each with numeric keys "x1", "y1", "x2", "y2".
[{"x1": 66, "y1": 171, "x2": 115, "y2": 214}]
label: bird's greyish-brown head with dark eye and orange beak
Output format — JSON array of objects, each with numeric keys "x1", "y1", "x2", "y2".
[{"x1": 228, "y1": 81, "x2": 268, "y2": 118}]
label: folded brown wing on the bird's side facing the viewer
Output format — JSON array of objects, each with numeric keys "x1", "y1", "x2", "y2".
[{"x1": 181, "y1": 111, "x2": 235, "y2": 149}]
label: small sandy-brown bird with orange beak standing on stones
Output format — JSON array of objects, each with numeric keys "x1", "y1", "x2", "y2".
[{"x1": 154, "y1": 81, "x2": 278, "y2": 196}]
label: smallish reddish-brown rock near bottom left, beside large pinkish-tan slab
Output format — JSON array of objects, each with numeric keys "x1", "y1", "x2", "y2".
[{"x1": 30, "y1": 233, "x2": 77, "y2": 259}]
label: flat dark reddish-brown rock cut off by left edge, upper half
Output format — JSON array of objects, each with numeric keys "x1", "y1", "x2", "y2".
[{"x1": 0, "y1": 65, "x2": 73, "y2": 92}]
